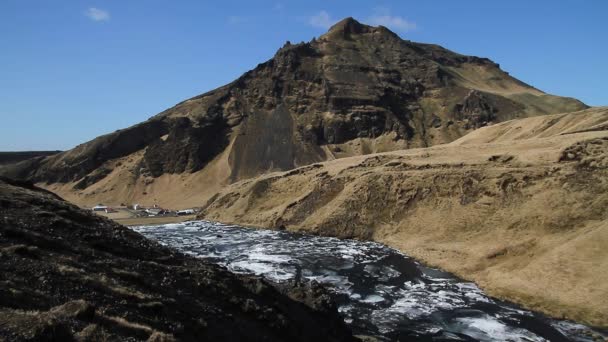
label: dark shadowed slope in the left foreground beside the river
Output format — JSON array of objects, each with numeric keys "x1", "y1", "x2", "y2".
[{"x1": 0, "y1": 180, "x2": 352, "y2": 341}]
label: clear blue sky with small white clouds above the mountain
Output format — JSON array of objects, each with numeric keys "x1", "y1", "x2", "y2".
[{"x1": 0, "y1": 0, "x2": 608, "y2": 151}]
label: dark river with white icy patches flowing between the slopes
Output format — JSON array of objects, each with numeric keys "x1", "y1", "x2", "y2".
[{"x1": 134, "y1": 221, "x2": 606, "y2": 341}]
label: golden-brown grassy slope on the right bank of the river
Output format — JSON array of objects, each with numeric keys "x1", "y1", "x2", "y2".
[{"x1": 201, "y1": 107, "x2": 608, "y2": 327}]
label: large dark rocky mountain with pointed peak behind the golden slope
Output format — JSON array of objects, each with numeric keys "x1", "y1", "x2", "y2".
[{"x1": 4, "y1": 18, "x2": 587, "y2": 206}]
